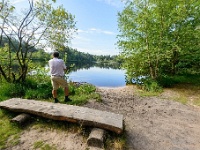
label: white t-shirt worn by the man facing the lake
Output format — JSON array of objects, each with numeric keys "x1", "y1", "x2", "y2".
[{"x1": 49, "y1": 58, "x2": 66, "y2": 76}]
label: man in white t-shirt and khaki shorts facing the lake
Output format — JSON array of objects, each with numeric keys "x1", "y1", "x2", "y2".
[{"x1": 49, "y1": 51, "x2": 71, "y2": 103}]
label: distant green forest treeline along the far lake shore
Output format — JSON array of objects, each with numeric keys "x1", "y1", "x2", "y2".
[{"x1": 0, "y1": 37, "x2": 120, "y2": 63}]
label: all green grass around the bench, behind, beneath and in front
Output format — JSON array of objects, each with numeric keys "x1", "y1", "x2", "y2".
[{"x1": 0, "y1": 76, "x2": 101, "y2": 150}]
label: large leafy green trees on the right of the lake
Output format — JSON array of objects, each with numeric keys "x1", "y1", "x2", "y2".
[{"x1": 117, "y1": 0, "x2": 200, "y2": 79}]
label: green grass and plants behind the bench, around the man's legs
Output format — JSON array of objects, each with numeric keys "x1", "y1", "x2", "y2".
[{"x1": 0, "y1": 76, "x2": 101, "y2": 105}]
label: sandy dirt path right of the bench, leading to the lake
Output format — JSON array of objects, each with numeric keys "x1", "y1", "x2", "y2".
[{"x1": 86, "y1": 86, "x2": 200, "y2": 150}]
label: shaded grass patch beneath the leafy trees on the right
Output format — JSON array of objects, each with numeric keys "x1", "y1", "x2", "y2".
[{"x1": 136, "y1": 75, "x2": 200, "y2": 106}]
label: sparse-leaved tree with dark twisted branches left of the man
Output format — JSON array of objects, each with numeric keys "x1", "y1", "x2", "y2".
[{"x1": 0, "y1": 0, "x2": 76, "y2": 82}]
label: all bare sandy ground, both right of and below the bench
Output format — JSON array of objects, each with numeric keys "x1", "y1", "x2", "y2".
[{"x1": 5, "y1": 86, "x2": 200, "y2": 150}]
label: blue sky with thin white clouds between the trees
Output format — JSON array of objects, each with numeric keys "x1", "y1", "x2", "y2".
[{"x1": 12, "y1": 0, "x2": 123, "y2": 55}]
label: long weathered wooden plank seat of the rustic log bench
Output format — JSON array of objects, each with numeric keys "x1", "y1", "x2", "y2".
[{"x1": 0, "y1": 98, "x2": 123, "y2": 134}]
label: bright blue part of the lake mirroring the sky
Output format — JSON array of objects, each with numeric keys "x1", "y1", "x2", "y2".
[{"x1": 68, "y1": 67, "x2": 126, "y2": 87}]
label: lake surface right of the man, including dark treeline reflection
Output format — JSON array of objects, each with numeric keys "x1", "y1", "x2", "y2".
[{"x1": 67, "y1": 63, "x2": 126, "y2": 87}]
